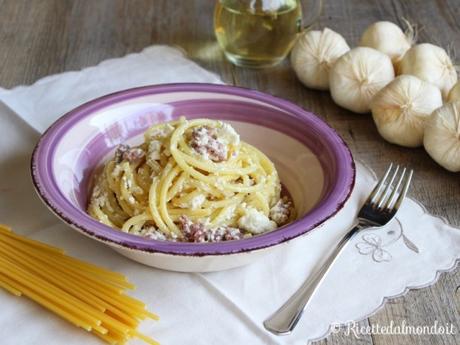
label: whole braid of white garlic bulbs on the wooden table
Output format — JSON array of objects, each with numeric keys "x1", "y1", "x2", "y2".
[{"x1": 291, "y1": 21, "x2": 460, "y2": 171}]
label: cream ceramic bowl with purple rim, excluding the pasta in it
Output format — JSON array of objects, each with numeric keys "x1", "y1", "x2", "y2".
[{"x1": 31, "y1": 84, "x2": 355, "y2": 272}]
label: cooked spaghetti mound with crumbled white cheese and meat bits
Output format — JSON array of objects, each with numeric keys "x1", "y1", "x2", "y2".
[{"x1": 88, "y1": 117, "x2": 294, "y2": 242}]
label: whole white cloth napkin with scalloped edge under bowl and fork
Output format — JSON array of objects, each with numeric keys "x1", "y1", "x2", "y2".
[{"x1": 0, "y1": 46, "x2": 460, "y2": 345}]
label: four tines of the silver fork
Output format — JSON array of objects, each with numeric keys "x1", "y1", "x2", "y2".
[{"x1": 366, "y1": 163, "x2": 414, "y2": 212}]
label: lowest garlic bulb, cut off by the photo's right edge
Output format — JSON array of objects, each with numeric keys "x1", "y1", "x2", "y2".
[{"x1": 423, "y1": 101, "x2": 460, "y2": 172}]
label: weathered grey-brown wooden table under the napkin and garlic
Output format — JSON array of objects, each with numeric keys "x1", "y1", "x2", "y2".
[{"x1": 0, "y1": 0, "x2": 460, "y2": 345}]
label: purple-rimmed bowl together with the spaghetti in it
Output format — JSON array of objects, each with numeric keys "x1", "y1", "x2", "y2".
[{"x1": 31, "y1": 84, "x2": 355, "y2": 272}]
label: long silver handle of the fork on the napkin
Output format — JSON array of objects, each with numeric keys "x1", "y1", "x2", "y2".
[{"x1": 264, "y1": 224, "x2": 362, "y2": 335}]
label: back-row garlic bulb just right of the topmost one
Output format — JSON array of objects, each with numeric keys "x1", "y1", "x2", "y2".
[{"x1": 400, "y1": 43, "x2": 457, "y2": 98}]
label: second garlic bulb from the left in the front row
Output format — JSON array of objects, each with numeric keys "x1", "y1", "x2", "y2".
[{"x1": 329, "y1": 47, "x2": 395, "y2": 113}]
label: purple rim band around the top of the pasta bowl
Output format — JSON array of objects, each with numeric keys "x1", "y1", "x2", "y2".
[{"x1": 30, "y1": 83, "x2": 356, "y2": 256}]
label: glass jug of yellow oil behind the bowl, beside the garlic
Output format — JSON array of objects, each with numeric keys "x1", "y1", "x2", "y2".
[{"x1": 214, "y1": 0, "x2": 322, "y2": 68}]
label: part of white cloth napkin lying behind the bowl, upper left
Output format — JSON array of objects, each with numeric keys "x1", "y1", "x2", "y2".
[{"x1": 0, "y1": 46, "x2": 222, "y2": 132}]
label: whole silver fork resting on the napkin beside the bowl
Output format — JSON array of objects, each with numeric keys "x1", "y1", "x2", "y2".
[{"x1": 264, "y1": 163, "x2": 413, "y2": 335}]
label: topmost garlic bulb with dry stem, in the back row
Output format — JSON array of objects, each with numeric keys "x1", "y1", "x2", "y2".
[{"x1": 359, "y1": 21, "x2": 415, "y2": 65}]
